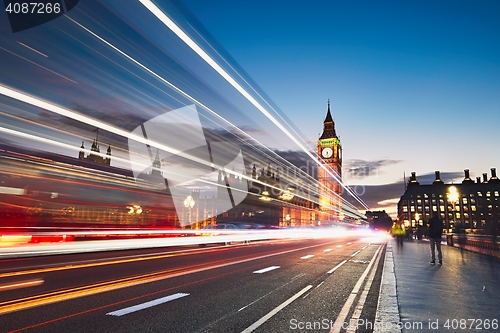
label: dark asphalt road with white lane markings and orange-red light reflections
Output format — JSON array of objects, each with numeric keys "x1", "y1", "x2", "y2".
[{"x1": 0, "y1": 235, "x2": 385, "y2": 333}]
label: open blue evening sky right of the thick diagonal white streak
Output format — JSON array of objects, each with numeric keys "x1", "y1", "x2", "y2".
[{"x1": 182, "y1": 0, "x2": 500, "y2": 192}]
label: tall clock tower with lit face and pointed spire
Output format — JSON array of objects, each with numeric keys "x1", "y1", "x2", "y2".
[{"x1": 318, "y1": 100, "x2": 342, "y2": 221}]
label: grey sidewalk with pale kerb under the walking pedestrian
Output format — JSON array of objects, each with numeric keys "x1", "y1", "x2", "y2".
[{"x1": 375, "y1": 240, "x2": 500, "y2": 333}]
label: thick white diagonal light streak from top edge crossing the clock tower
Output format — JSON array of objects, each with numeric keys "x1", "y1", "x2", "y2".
[{"x1": 139, "y1": 0, "x2": 368, "y2": 209}]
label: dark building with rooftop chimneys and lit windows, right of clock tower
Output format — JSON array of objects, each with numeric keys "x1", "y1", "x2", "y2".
[{"x1": 398, "y1": 168, "x2": 500, "y2": 234}]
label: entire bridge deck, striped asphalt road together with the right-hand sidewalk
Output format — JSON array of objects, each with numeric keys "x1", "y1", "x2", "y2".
[{"x1": 0, "y1": 236, "x2": 500, "y2": 333}]
